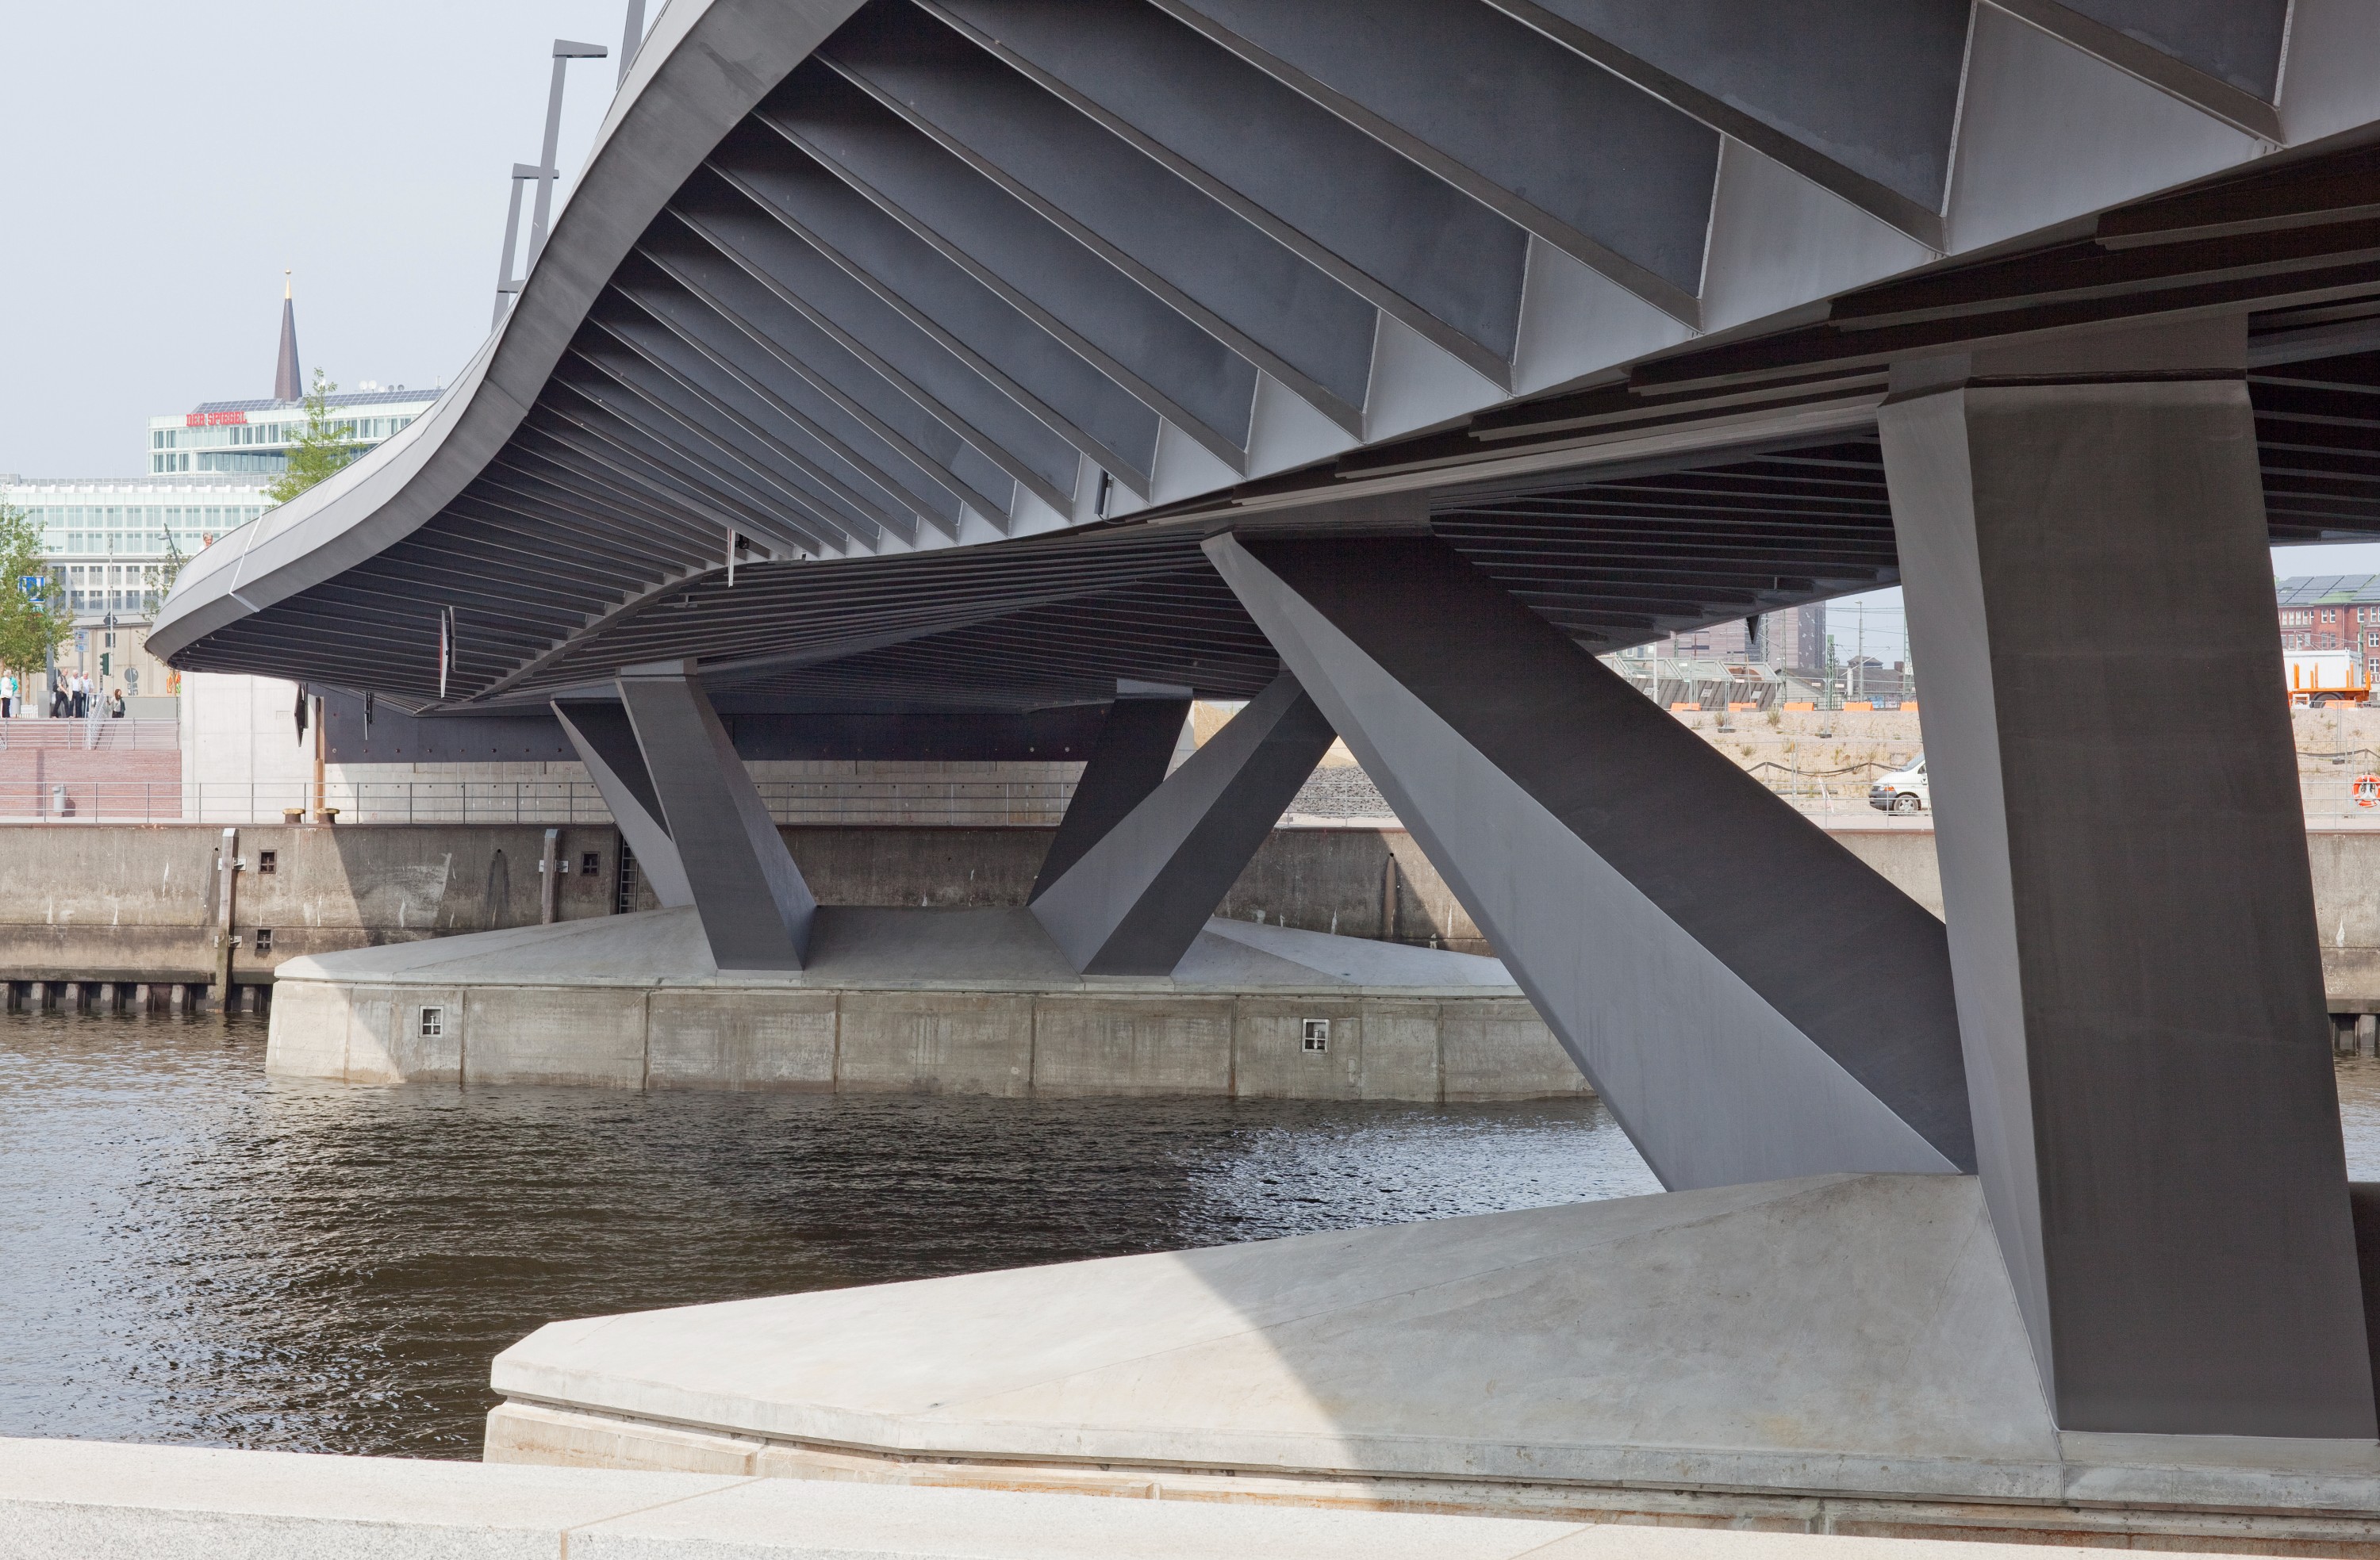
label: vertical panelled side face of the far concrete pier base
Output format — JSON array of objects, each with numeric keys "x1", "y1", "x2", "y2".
[{"x1": 267, "y1": 979, "x2": 1592, "y2": 1101}]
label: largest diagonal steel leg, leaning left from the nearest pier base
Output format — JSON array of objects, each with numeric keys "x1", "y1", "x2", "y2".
[{"x1": 1207, "y1": 535, "x2": 1975, "y2": 1189}]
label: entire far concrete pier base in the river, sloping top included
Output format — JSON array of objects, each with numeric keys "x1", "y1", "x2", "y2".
[{"x1": 267, "y1": 906, "x2": 1590, "y2": 1101}]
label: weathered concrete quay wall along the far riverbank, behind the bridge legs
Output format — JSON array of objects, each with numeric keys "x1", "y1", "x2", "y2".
[{"x1": 13, "y1": 815, "x2": 2380, "y2": 1013}]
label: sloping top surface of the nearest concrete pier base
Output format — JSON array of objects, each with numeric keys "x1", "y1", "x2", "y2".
[{"x1": 490, "y1": 1175, "x2": 2059, "y2": 1498}]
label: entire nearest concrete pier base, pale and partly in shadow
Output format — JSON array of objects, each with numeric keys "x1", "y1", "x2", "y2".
[{"x1": 486, "y1": 1175, "x2": 2380, "y2": 1555}]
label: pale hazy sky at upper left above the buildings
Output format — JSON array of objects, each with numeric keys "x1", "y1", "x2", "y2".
[{"x1": 0, "y1": 0, "x2": 643, "y2": 476}]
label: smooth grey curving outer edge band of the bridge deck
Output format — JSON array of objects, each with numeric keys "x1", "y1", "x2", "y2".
[{"x1": 148, "y1": 0, "x2": 859, "y2": 659}]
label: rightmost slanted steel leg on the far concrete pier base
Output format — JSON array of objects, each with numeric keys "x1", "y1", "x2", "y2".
[{"x1": 1033, "y1": 673, "x2": 1333, "y2": 975}]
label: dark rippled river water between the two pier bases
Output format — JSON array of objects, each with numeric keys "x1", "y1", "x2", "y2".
[{"x1": 0, "y1": 1013, "x2": 1666, "y2": 1455}]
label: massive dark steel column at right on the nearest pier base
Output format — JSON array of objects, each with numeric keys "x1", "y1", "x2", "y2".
[{"x1": 1880, "y1": 319, "x2": 2373, "y2": 1441}]
